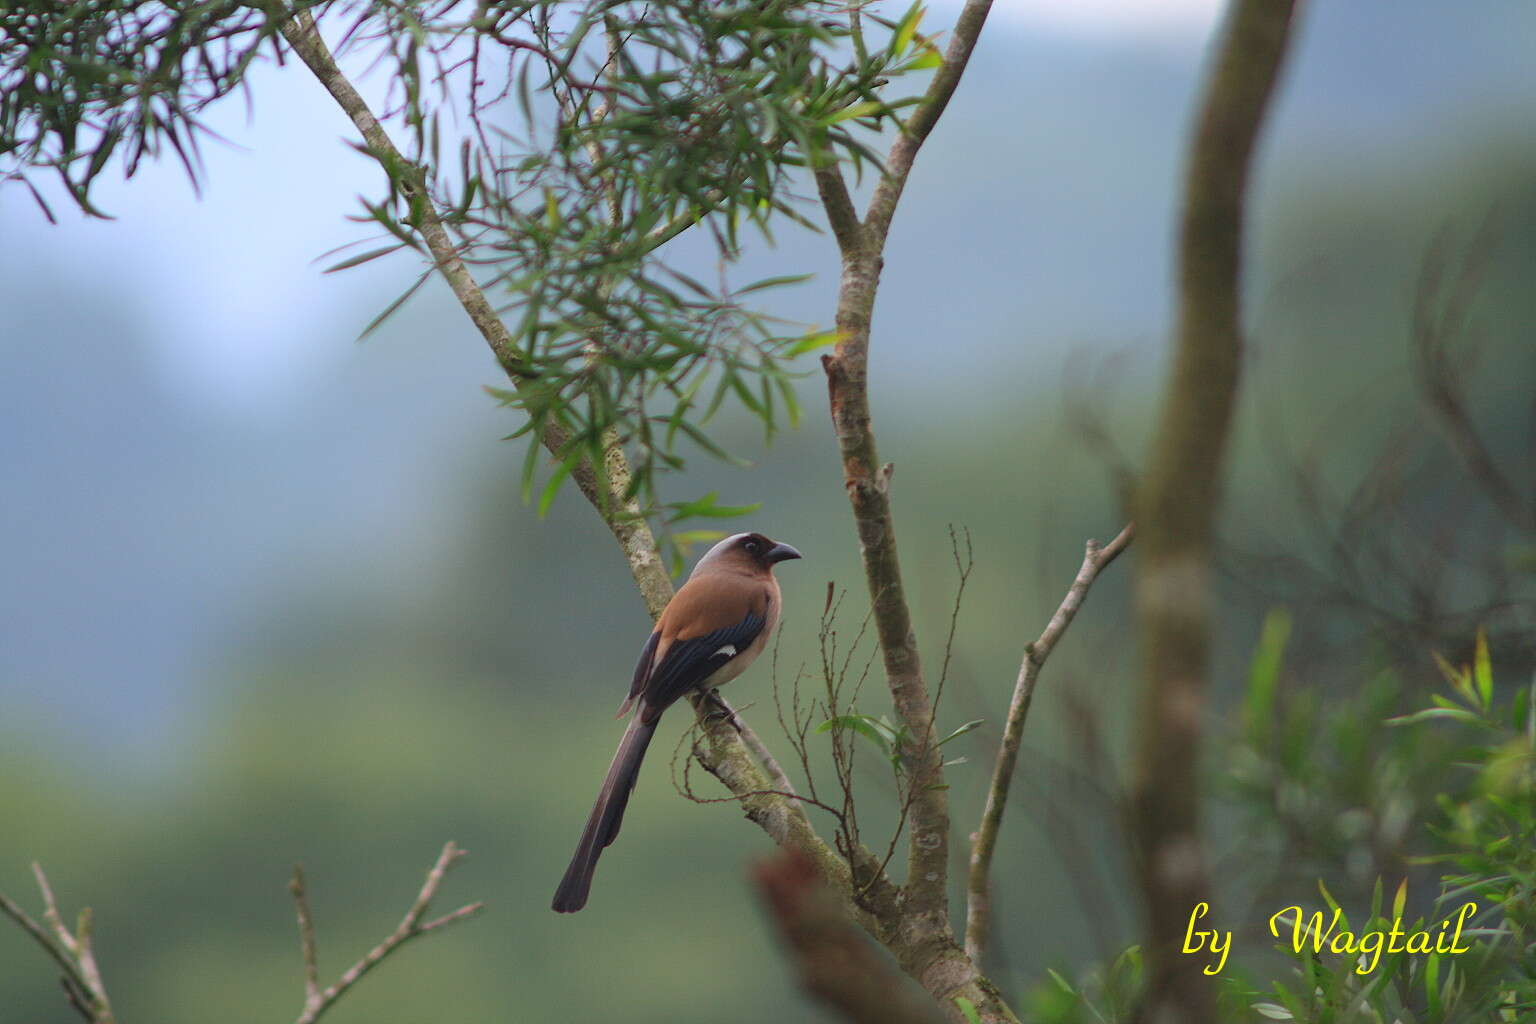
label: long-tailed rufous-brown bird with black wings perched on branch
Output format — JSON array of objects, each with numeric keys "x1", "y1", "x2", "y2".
[{"x1": 551, "y1": 533, "x2": 802, "y2": 913}]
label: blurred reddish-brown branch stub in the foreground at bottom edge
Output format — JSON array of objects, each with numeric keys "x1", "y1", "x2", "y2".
[{"x1": 753, "y1": 851, "x2": 945, "y2": 1024}]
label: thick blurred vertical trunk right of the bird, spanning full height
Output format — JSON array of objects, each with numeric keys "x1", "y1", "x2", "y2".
[{"x1": 1132, "y1": 0, "x2": 1295, "y2": 1024}]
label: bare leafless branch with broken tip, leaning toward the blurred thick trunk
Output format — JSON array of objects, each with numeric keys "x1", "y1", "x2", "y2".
[{"x1": 965, "y1": 524, "x2": 1135, "y2": 966}]
